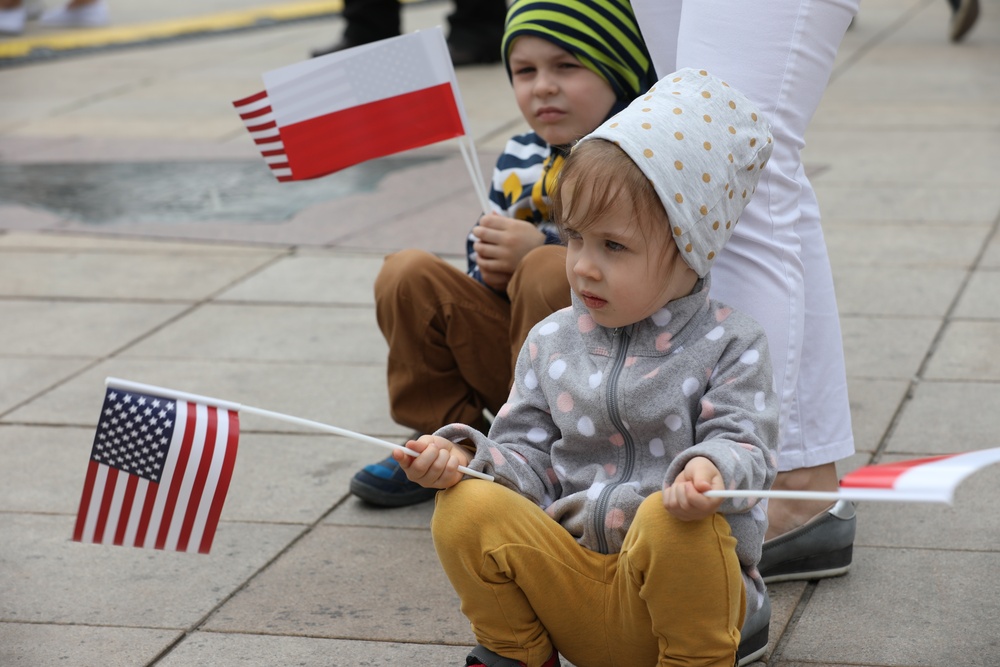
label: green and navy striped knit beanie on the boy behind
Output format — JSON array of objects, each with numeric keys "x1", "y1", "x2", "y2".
[{"x1": 501, "y1": 0, "x2": 656, "y2": 103}]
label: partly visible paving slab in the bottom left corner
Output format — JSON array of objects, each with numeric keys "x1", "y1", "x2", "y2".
[{"x1": 0, "y1": 622, "x2": 181, "y2": 667}]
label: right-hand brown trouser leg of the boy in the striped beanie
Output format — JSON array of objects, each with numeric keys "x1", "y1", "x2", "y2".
[{"x1": 507, "y1": 245, "x2": 572, "y2": 373}]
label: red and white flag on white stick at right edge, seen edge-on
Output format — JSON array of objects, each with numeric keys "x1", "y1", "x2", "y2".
[{"x1": 705, "y1": 447, "x2": 1000, "y2": 504}]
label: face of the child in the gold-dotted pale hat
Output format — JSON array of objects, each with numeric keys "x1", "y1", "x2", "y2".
[{"x1": 562, "y1": 183, "x2": 698, "y2": 328}]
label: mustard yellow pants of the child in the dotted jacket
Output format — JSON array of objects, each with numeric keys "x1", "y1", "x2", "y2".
[{"x1": 431, "y1": 479, "x2": 746, "y2": 667}]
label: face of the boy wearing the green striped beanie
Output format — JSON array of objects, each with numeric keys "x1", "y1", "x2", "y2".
[{"x1": 510, "y1": 35, "x2": 616, "y2": 146}]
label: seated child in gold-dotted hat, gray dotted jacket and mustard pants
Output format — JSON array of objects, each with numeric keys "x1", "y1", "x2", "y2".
[{"x1": 394, "y1": 69, "x2": 778, "y2": 667}]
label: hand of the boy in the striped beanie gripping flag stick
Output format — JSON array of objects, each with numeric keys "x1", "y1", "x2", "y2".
[{"x1": 472, "y1": 213, "x2": 545, "y2": 291}]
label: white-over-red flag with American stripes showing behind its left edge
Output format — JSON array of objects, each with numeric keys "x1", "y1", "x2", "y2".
[{"x1": 233, "y1": 28, "x2": 468, "y2": 181}]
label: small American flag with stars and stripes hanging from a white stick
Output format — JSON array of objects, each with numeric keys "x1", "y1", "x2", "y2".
[{"x1": 73, "y1": 387, "x2": 240, "y2": 554}]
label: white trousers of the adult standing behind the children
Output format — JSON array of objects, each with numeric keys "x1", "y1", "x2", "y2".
[{"x1": 632, "y1": 0, "x2": 858, "y2": 470}]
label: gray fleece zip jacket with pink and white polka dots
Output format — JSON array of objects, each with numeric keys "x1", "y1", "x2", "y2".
[{"x1": 436, "y1": 277, "x2": 778, "y2": 609}]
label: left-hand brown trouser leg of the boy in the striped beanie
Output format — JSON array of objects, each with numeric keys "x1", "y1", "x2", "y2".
[{"x1": 375, "y1": 250, "x2": 511, "y2": 433}]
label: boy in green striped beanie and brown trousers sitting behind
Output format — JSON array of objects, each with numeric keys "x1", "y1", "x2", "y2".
[{"x1": 351, "y1": 0, "x2": 656, "y2": 507}]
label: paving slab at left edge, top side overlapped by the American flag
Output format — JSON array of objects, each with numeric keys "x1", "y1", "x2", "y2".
[{"x1": 0, "y1": 516, "x2": 303, "y2": 629}]
